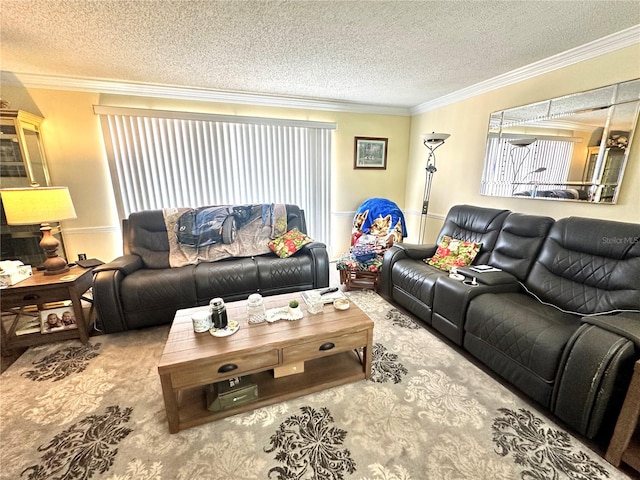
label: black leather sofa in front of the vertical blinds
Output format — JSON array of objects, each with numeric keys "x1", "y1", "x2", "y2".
[{"x1": 93, "y1": 205, "x2": 329, "y2": 333}]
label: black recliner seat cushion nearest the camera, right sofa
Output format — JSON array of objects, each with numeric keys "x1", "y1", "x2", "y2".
[{"x1": 465, "y1": 293, "x2": 581, "y2": 406}]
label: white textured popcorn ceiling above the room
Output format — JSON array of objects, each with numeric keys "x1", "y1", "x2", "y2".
[{"x1": 0, "y1": 0, "x2": 640, "y2": 107}]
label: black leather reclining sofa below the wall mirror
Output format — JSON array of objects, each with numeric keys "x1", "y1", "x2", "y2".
[{"x1": 381, "y1": 205, "x2": 640, "y2": 439}]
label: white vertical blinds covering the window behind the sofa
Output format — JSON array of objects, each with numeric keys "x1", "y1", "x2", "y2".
[{"x1": 94, "y1": 106, "x2": 335, "y2": 243}]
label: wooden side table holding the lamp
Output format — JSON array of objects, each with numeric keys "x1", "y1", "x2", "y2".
[{"x1": 0, "y1": 266, "x2": 93, "y2": 355}]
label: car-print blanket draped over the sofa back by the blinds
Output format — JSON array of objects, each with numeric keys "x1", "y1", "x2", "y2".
[{"x1": 162, "y1": 203, "x2": 287, "y2": 267}]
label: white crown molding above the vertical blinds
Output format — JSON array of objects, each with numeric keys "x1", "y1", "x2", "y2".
[{"x1": 1, "y1": 71, "x2": 410, "y2": 117}]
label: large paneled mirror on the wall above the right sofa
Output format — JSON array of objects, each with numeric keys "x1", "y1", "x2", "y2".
[{"x1": 480, "y1": 79, "x2": 640, "y2": 204}]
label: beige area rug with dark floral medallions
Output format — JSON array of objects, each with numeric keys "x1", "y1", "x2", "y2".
[{"x1": 0, "y1": 291, "x2": 628, "y2": 480}]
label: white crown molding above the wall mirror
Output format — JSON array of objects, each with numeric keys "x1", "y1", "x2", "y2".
[{"x1": 410, "y1": 25, "x2": 640, "y2": 116}]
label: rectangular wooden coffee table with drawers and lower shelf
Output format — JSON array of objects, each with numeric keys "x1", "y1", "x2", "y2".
[{"x1": 158, "y1": 293, "x2": 373, "y2": 433}]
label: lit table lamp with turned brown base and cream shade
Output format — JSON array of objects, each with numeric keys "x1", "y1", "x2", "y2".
[{"x1": 0, "y1": 186, "x2": 77, "y2": 275}]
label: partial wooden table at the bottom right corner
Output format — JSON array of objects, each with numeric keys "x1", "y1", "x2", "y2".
[{"x1": 605, "y1": 360, "x2": 640, "y2": 472}]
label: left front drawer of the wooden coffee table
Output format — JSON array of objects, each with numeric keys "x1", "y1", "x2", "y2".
[{"x1": 171, "y1": 350, "x2": 279, "y2": 388}]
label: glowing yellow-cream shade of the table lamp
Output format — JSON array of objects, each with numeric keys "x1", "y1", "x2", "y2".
[{"x1": 0, "y1": 187, "x2": 77, "y2": 225}]
